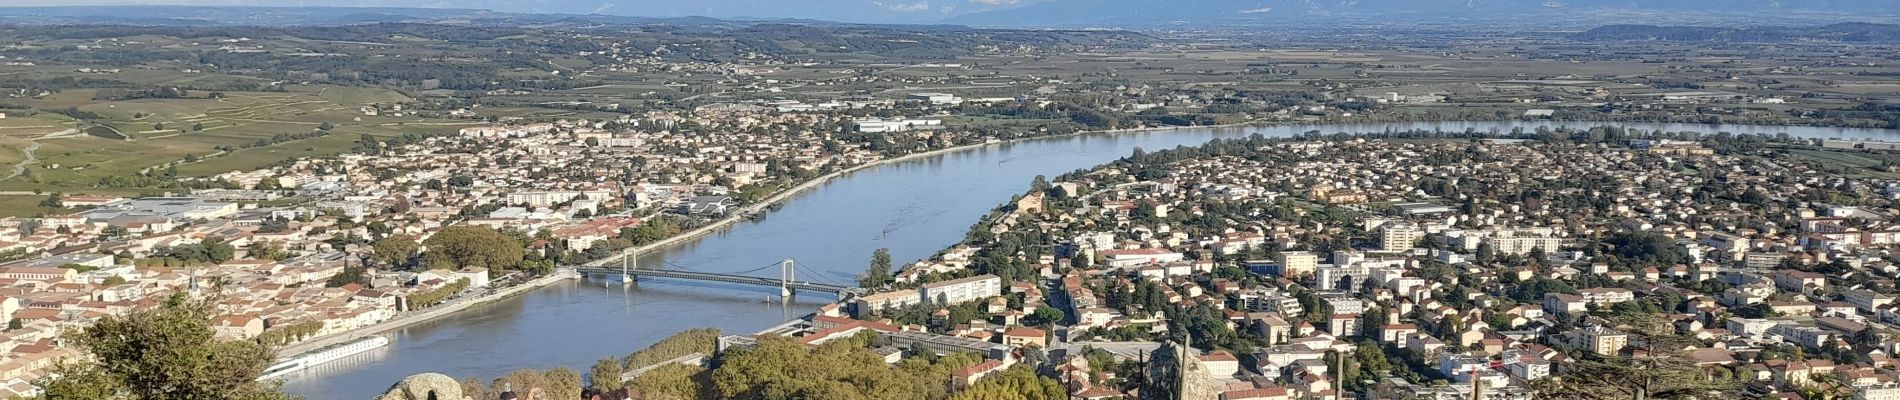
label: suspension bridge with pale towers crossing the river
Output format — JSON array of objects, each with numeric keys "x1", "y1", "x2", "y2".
[{"x1": 574, "y1": 254, "x2": 865, "y2": 298}]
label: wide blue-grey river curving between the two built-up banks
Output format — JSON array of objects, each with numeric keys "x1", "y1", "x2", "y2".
[{"x1": 285, "y1": 121, "x2": 1900, "y2": 400}]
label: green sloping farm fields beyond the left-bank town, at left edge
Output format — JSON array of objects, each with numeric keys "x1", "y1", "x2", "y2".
[{"x1": 0, "y1": 85, "x2": 481, "y2": 191}]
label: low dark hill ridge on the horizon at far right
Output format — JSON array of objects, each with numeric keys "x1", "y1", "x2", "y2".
[{"x1": 1575, "y1": 23, "x2": 1900, "y2": 44}]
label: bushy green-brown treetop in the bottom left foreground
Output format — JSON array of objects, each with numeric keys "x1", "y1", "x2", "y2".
[{"x1": 40, "y1": 294, "x2": 296, "y2": 400}]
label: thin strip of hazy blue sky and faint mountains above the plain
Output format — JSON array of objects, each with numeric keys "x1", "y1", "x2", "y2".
[{"x1": 0, "y1": 0, "x2": 1900, "y2": 27}]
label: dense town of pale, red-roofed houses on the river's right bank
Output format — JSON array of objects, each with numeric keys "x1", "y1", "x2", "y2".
[{"x1": 648, "y1": 127, "x2": 1900, "y2": 398}]
